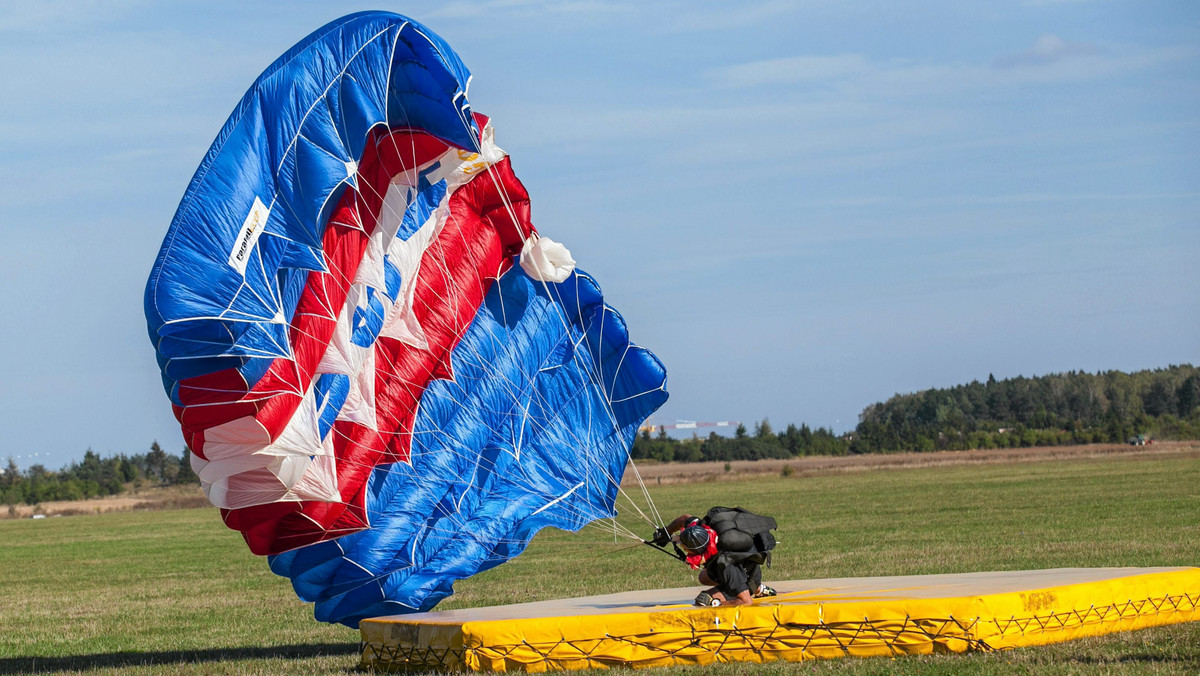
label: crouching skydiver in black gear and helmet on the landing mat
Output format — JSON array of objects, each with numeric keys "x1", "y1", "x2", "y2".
[{"x1": 648, "y1": 507, "x2": 775, "y2": 606}]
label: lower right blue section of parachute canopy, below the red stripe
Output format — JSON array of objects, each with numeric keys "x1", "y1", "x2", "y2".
[{"x1": 271, "y1": 267, "x2": 667, "y2": 627}]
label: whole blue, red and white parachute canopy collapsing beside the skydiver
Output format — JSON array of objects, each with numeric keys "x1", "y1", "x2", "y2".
[{"x1": 145, "y1": 12, "x2": 667, "y2": 626}]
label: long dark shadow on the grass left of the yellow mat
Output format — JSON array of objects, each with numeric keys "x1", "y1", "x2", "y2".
[{"x1": 0, "y1": 644, "x2": 361, "y2": 674}]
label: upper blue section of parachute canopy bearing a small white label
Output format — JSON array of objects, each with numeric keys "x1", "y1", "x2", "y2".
[{"x1": 145, "y1": 12, "x2": 479, "y2": 403}]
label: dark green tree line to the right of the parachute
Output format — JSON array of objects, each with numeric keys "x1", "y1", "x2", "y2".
[{"x1": 632, "y1": 365, "x2": 1200, "y2": 462}]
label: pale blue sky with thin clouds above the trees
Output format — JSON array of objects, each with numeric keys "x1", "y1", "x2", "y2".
[{"x1": 0, "y1": 0, "x2": 1200, "y2": 468}]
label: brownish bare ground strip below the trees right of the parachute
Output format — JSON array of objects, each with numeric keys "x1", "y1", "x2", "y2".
[{"x1": 623, "y1": 442, "x2": 1200, "y2": 484}]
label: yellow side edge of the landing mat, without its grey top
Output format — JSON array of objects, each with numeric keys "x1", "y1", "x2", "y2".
[{"x1": 361, "y1": 568, "x2": 1200, "y2": 672}]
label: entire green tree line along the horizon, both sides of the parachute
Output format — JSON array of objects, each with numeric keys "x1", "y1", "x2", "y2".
[{"x1": 11, "y1": 364, "x2": 1200, "y2": 489}]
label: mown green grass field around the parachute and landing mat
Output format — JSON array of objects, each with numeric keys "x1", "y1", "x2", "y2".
[{"x1": 0, "y1": 445, "x2": 1200, "y2": 675}]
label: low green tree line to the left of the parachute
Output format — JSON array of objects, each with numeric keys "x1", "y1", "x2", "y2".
[{"x1": 0, "y1": 442, "x2": 199, "y2": 505}]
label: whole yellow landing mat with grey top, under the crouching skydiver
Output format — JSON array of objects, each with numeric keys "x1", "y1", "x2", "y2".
[{"x1": 361, "y1": 568, "x2": 1200, "y2": 671}]
